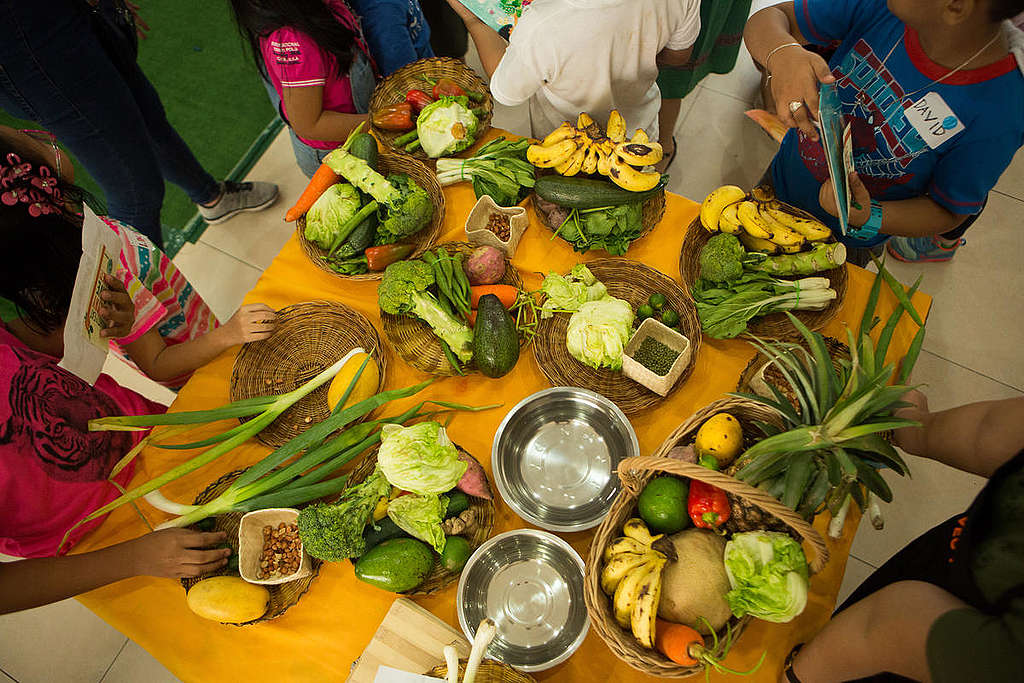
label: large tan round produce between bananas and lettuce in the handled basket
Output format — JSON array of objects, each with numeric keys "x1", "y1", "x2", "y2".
[{"x1": 657, "y1": 528, "x2": 732, "y2": 635}]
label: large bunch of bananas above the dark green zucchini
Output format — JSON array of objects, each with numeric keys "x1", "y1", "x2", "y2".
[{"x1": 526, "y1": 110, "x2": 663, "y2": 193}]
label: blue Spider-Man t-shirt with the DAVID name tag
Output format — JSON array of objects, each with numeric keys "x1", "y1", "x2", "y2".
[{"x1": 772, "y1": 0, "x2": 1024, "y2": 247}]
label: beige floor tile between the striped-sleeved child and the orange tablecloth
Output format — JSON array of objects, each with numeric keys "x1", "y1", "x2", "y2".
[{"x1": 174, "y1": 242, "x2": 262, "y2": 322}]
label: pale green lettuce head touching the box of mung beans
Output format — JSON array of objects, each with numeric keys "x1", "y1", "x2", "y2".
[{"x1": 565, "y1": 296, "x2": 633, "y2": 370}]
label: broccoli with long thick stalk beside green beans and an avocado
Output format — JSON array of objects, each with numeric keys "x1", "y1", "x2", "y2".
[{"x1": 377, "y1": 259, "x2": 473, "y2": 362}]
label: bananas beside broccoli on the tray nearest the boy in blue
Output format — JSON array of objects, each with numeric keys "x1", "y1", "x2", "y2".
[{"x1": 700, "y1": 185, "x2": 831, "y2": 254}]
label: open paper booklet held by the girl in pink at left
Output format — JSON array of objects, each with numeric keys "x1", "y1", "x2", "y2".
[{"x1": 59, "y1": 207, "x2": 121, "y2": 384}]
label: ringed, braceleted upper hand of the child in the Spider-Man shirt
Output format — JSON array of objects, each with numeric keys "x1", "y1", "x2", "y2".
[{"x1": 771, "y1": 47, "x2": 836, "y2": 140}]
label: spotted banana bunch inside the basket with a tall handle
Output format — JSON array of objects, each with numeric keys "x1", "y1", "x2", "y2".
[{"x1": 601, "y1": 517, "x2": 668, "y2": 647}]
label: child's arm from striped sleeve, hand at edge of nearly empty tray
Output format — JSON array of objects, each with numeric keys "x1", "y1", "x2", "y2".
[{"x1": 125, "y1": 303, "x2": 276, "y2": 382}]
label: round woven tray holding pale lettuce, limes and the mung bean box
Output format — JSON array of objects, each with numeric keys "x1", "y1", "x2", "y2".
[{"x1": 534, "y1": 258, "x2": 700, "y2": 415}]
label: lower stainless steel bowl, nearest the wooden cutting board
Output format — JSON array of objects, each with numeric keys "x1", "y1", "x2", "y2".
[{"x1": 456, "y1": 528, "x2": 590, "y2": 672}]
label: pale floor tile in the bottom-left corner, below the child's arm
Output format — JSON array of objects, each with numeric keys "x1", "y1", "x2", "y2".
[{"x1": 0, "y1": 600, "x2": 127, "y2": 683}]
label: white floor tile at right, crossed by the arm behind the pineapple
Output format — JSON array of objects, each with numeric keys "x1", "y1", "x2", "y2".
[{"x1": 850, "y1": 352, "x2": 1021, "y2": 566}]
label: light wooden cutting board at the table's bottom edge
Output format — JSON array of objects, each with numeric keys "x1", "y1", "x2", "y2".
[{"x1": 348, "y1": 598, "x2": 470, "y2": 683}]
